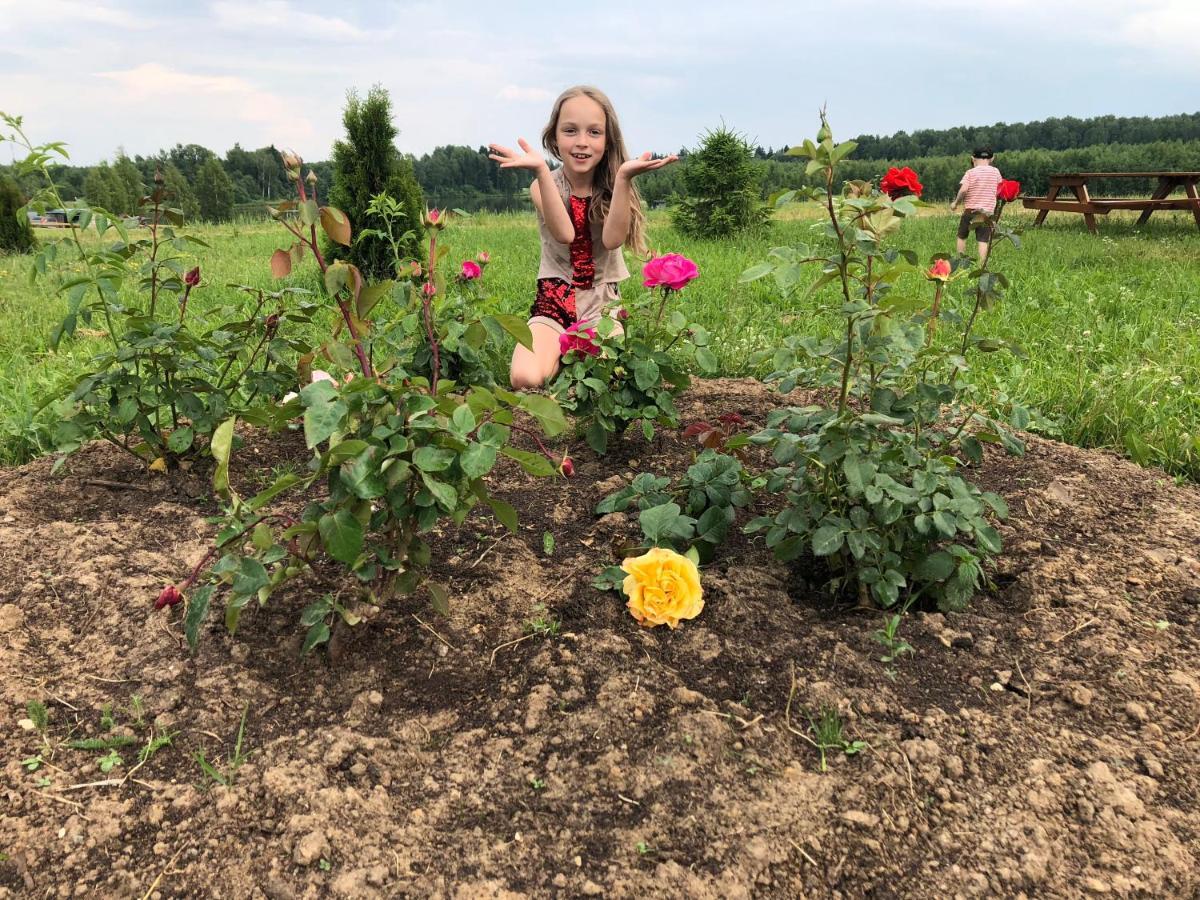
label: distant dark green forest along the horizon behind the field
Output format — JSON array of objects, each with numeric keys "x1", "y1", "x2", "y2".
[{"x1": 0, "y1": 113, "x2": 1200, "y2": 221}]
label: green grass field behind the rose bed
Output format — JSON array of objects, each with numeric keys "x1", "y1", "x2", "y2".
[{"x1": 0, "y1": 209, "x2": 1200, "y2": 480}]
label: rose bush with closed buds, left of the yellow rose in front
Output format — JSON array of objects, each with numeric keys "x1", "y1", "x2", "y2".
[{"x1": 170, "y1": 154, "x2": 566, "y2": 649}]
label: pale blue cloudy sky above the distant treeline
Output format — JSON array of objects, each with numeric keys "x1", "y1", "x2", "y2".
[{"x1": 0, "y1": 0, "x2": 1200, "y2": 163}]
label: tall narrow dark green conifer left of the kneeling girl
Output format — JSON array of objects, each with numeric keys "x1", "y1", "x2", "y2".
[{"x1": 322, "y1": 85, "x2": 425, "y2": 281}]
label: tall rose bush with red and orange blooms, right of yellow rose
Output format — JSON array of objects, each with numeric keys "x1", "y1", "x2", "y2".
[{"x1": 743, "y1": 115, "x2": 1028, "y2": 610}]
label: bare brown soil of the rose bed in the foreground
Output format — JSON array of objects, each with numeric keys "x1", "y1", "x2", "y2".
[{"x1": 0, "y1": 382, "x2": 1200, "y2": 898}]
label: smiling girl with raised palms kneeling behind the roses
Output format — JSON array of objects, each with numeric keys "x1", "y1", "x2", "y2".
[{"x1": 488, "y1": 85, "x2": 678, "y2": 390}]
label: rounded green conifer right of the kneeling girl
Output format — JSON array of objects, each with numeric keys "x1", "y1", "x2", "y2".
[{"x1": 671, "y1": 126, "x2": 768, "y2": 238}]
